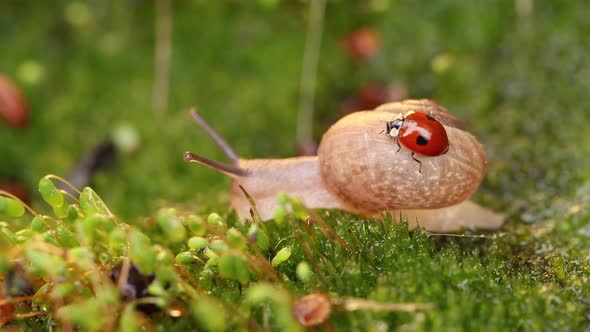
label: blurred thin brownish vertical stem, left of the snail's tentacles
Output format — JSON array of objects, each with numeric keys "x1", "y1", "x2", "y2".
[{"x1": 152, "y1": 0, "x2": 172, "y2": 113}]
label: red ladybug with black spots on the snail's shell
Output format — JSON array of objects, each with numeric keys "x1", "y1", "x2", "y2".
[{"x1": 385, "y1": 111, "x2": 449, "y2": 173}]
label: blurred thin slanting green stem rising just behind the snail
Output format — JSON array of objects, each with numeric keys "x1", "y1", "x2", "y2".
[{"x1": 297, "y1": 0, "x2": 326, "y2": 145}]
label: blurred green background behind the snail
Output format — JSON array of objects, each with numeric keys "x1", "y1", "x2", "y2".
[{"x1": 0, "y1": 0, "x2": 590, "y2": 223}]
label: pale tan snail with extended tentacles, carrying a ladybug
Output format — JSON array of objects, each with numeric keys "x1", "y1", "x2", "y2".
[{"x1": 184, "y1": 99, "x2": 504, "y2": 232}]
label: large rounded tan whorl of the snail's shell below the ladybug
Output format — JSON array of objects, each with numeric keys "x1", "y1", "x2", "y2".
[{"x1": 318, "y1": 111, "x2": 486, "y2": 213}]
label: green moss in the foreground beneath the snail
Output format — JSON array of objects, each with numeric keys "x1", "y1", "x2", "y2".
[{"x1": 0, "y1": 182, "x2": 590, "y2": 330}]
